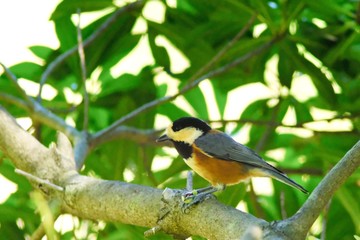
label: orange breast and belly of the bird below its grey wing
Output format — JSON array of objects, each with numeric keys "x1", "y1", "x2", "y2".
[{"x1": 186, "y1": 143, "x2": 250, "y2": 185}]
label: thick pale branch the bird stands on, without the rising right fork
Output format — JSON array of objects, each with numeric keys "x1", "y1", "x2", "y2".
[{"x1": 0, "y1": 108, "x2": 269, "y2": 239}]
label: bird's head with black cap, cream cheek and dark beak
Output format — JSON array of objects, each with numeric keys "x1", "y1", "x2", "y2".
[{"x1": 156, "y1": 117, "x2": 211, "y2": 145}]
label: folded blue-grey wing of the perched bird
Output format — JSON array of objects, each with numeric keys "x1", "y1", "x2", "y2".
[{"x1": 195, "y1": 132, "x2": 282, "y2": 173}]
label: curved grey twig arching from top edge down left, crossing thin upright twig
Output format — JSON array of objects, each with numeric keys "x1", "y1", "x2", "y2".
[{"x1": 37, "y1": 0, "x2": 144, "y2": 102}]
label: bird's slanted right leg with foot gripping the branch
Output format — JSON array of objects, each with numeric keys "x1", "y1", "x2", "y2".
[{"x1": 181, "y1": 185, "x2": 225, "y2": 210}]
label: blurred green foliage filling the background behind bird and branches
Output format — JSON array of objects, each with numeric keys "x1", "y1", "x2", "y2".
[{"x1": 0, "y1": 0, "x2": 360, "y2": 240}]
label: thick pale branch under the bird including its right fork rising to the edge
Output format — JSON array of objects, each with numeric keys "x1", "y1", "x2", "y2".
[{"x1": 0, "y1": 99, "x2": 360, "y2": 239}]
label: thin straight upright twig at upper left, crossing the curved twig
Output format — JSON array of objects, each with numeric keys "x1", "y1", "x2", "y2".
[{"x1": 76, "y1": 9, "x2": 89, "y2": 130}]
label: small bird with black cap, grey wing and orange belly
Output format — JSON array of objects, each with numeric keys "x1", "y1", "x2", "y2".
[{"x1": 157, "y1": 117, "x2": 308, "y2": 206}]
